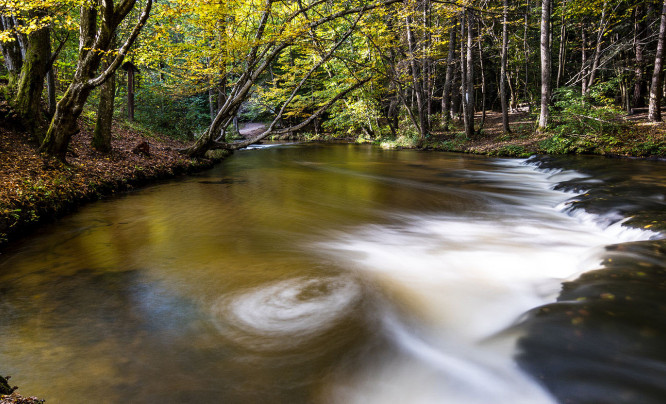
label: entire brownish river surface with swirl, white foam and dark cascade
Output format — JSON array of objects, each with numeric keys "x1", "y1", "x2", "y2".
[{"x1": 0, "y1": 145, "x2": 666, "y2": 404}]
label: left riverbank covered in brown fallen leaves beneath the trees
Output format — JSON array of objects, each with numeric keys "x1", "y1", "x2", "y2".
[{"x1": 0, "y1": 121, "x2": 213, "y2": 250}]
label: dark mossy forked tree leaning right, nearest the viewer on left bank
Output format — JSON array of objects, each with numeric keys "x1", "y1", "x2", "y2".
[{"x1": 40, "y1": 0, "x2": 153, "y2": 161}]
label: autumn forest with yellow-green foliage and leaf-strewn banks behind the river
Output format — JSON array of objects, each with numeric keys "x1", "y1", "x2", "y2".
[{"x1": 0, "y1": 0, "x2": 666, "y2": 252}]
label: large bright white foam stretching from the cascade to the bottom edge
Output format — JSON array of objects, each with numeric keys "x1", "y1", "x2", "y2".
[{"x1": 318, "y1": 160, "x2": 654, "y2": 403}]
